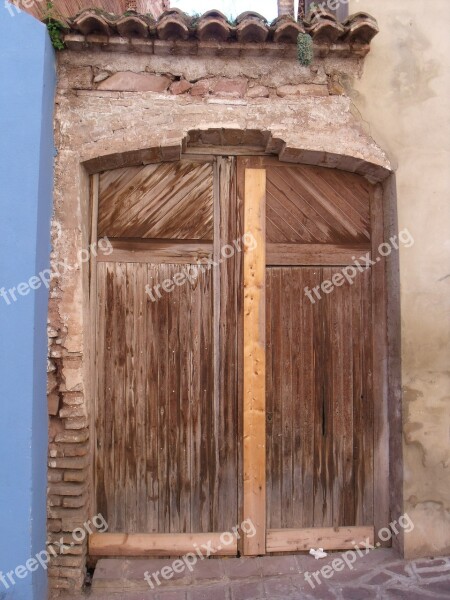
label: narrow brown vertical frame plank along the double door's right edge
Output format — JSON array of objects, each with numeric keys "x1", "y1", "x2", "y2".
[{"x1": 370, "y1": 184, "x2": 390, "y2": 545}]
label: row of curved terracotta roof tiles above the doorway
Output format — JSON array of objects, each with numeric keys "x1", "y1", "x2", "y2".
[{"x1": 61, "y1": 8, "x2": 379, "y2": 55}]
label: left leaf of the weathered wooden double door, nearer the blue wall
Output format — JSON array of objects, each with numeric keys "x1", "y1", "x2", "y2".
[{"x1": 90, "y1": 158, "x2": 240, "y2": 555}]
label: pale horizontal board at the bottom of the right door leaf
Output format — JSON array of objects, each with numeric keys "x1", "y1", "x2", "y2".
[{"x1": 267, "y1": 526, "x2": 375, "y2": 552}]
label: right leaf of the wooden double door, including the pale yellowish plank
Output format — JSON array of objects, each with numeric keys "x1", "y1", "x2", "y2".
[{"x1": 239, "y1": 158, "x2": 388, "y2": 554}]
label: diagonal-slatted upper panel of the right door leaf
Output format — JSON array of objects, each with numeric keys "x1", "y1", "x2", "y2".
[{"x1": 266, "y1": 164, "x2": 370, "y2": 244}]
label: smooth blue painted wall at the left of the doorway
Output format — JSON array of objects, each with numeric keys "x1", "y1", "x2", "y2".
[{"x1": 0, "y1": 8, "x2": 55, "y2": 600}]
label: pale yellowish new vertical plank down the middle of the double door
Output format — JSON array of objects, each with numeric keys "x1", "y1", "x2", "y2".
[{"x1": 243, "y1": 169, "x2": 266, "y2": 555}]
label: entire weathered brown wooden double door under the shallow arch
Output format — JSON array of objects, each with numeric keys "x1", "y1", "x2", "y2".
[{"x1": 90, "y1": 156, "x2": 388, "y2": 555}]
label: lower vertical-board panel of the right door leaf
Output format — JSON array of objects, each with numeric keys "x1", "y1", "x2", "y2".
[{"x1": 266, "y1": 267, "x2": 374, "y2": 529}]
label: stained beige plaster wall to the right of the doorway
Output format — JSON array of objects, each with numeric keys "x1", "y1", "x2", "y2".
[{"x1": 350, "y1": 0, "x2": 450, "y2": 556}]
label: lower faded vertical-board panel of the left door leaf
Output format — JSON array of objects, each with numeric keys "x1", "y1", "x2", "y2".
[{"x1": 96, "y1": 262, "x2": 237, "y2": 533}]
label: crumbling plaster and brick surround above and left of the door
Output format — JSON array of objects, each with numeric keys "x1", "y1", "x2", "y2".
[{"x1": 48, "y1": 45, "x2": 391, "y2": 588}]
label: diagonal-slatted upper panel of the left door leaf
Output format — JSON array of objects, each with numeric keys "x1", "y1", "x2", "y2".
[{"x1": 98, "y1": 161, "x2": 213, "y2": 240}]
